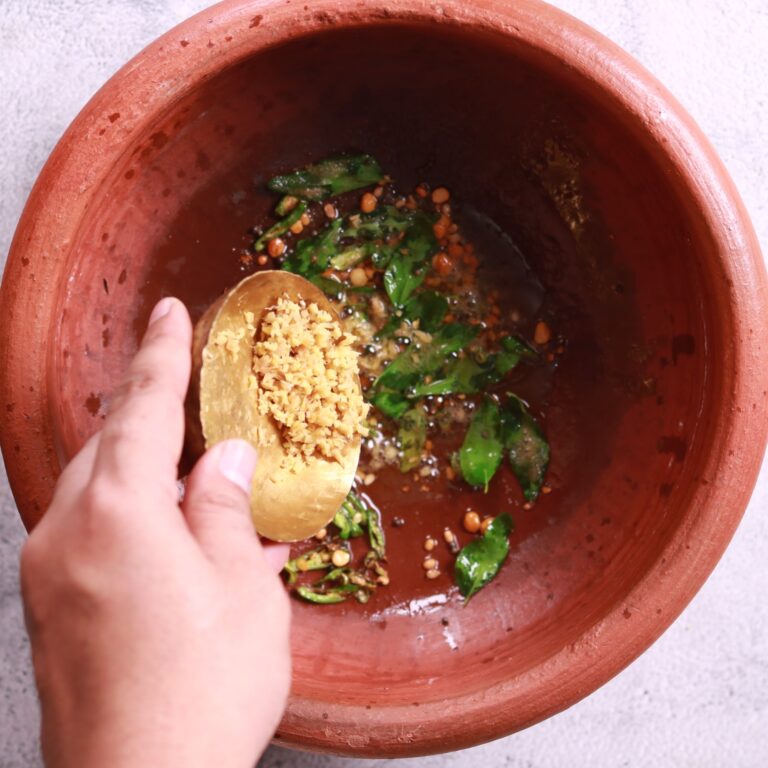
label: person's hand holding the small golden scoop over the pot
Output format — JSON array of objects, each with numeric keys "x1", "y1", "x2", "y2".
[{"x1": 21, "y1": 299, "x2": 290, "y2": 768}]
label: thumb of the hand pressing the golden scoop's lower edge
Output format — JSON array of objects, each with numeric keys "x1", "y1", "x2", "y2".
[{"x1": 182, "y1": 440, "x2": 288, "y2": 571}]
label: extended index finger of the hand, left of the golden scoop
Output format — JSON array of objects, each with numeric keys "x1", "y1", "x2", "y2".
[{"x1": 93, "y1": 297, "x2": 192, "y2": 492}]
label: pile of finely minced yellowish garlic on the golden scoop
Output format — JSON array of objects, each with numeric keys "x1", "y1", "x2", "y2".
[{"x1": 253, "y1": 298, "x2": 368, "y2": 461}]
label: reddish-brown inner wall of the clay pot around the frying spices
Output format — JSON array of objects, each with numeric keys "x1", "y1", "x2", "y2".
[{"x1": 49, "y1": 25, "x2": 717, "y2": 717}]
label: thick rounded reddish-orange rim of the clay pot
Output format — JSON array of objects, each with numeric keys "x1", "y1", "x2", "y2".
[{"x1": 0, "y1": 0, "x2": 768, "y2": 757}]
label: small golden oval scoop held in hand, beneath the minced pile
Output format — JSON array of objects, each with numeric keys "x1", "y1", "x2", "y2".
[{"x1": 187, "y1": 270, "x2": 361, "y2": 541}]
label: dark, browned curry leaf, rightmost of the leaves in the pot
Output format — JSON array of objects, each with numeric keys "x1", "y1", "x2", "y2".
[{"x1": 501, "y1": 394, "x2": 549, "y2": 501}]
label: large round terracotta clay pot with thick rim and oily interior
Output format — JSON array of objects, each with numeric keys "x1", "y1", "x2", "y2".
[{"x1": 0, "y1": 0, "x2": 768, "y2": 757}]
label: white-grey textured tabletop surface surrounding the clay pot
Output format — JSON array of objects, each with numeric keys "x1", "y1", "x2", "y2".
[{"x1": 0, "y1": 0, "x2": 768, "y2": 768}]
